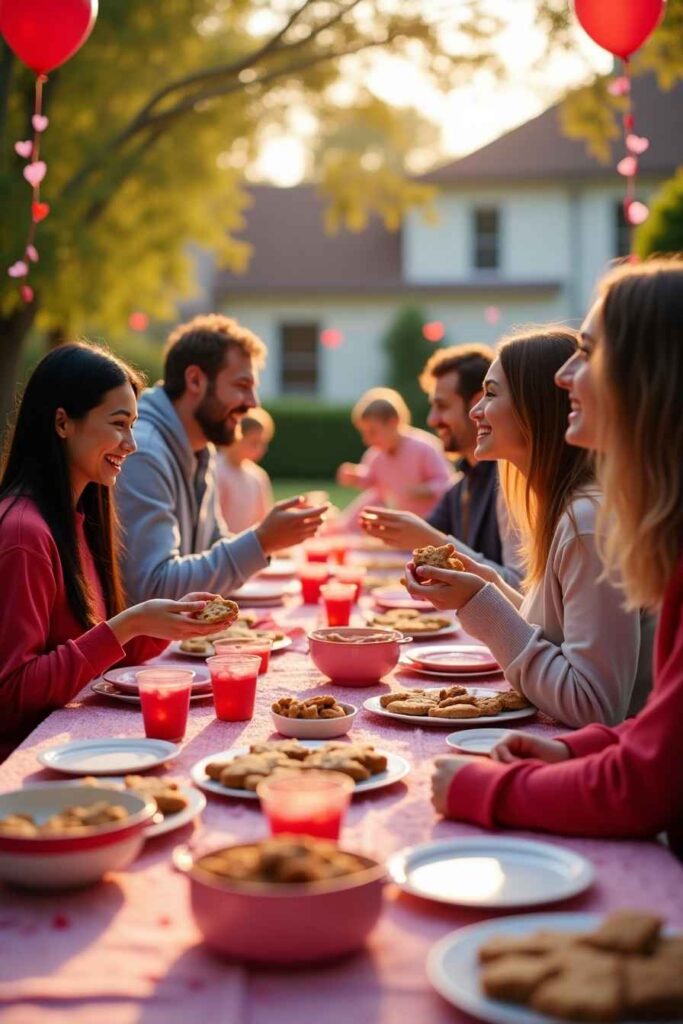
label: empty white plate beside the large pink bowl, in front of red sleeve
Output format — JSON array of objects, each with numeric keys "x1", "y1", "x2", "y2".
[{"x1": 387, "y1": 836, "x2": 594, "y2": 909}]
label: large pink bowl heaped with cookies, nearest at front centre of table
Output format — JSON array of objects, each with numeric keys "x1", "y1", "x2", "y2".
[{"x1": 174, "y1": 835, "x2": 385, "y2": 965}]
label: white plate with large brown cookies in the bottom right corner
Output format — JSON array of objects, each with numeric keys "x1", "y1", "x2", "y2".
[{"x1": 427, "y1": 910, "x2": 683, "y2": 1024}]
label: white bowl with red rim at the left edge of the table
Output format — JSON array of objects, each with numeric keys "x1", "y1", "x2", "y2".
[{"x1": 0, "y1": 782, "x2": 157, "y2": 889}]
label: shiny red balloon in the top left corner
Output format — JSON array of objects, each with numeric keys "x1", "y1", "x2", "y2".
[{"x1": 0, "y1": 0, "x2": 97, "y2": 75}]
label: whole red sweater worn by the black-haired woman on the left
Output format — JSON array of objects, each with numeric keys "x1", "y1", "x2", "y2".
[{"x1": 0, "y1": 499, "x2": 167, "y2": 759}]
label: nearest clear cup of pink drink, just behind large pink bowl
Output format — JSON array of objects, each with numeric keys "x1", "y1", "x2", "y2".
[{"x1": 256, "y1": 770, "x2": 355, "y2": 840}]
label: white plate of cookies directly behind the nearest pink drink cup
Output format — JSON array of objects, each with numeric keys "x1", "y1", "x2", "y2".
[{"x1": 190, "y1": 739, "x2": 411, "y2": 800}]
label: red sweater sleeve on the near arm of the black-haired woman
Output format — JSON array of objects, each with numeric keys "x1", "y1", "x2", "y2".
[{"x1": 0, "y1": 547, "x2": 124, "y2": 735}]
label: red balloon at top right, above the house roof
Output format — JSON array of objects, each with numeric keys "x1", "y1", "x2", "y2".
[{"x1": 573, "y1": 0, "x2": 666, "y2": 60}]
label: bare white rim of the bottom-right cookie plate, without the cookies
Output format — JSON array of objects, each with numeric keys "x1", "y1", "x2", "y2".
[{"x1": 427, "y1": 913, "x2": 663, "y2": 1024}]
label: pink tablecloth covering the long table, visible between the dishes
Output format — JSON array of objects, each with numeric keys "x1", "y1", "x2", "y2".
[{"x1": 0, "y1": 608, "x2": 683, "y2": 1024}]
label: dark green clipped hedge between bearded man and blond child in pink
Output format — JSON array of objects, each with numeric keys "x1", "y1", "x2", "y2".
[{"x1": 262, "y1": 398, "x2": 364, "y2": 480}]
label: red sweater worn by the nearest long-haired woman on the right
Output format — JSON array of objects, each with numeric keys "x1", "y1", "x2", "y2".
[{"x1": 447, "y1": 558, "x2": 683, "y2": 855}]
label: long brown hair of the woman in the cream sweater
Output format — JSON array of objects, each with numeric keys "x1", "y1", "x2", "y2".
[{"x1": 498, "y1": 326, "x2": 594, "y2": 587}]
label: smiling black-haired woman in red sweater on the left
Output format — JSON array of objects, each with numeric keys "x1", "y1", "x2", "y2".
[{"x1": 0, "y1": 344, "x2": 222, "y2": 760}]
